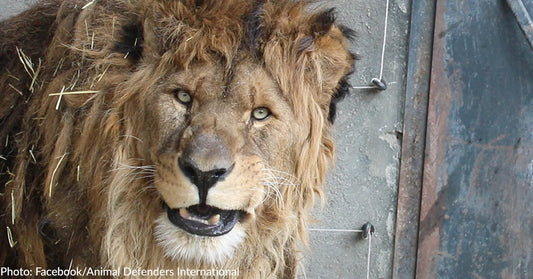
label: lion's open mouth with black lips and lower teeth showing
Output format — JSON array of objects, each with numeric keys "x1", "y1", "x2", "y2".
[{"x1": 165, "y1": 204, "x2": 243, "y2": 236}]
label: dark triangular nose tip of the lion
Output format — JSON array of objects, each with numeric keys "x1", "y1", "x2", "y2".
[{"x1": 178, "y1": 158, "x2": 234, "y2": 204}]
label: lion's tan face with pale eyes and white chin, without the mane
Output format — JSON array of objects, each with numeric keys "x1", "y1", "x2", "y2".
[{"x1": 139, "y1": 58, "x2": 305, "y2": 262}]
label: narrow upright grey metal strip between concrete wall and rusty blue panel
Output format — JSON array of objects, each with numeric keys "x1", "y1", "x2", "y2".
[{"x1": 393, "y1": 0, "x2": 435, "y2": 279}]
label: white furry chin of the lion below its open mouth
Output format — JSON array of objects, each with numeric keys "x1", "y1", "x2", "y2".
[{"x1": 155, "y1": 213, "x2": 246, "y2": 264}]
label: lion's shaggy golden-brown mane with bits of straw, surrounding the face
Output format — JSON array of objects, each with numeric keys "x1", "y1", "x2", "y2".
[{"x1": 0, "y1": 0, "x2": 354, "y2": 278}]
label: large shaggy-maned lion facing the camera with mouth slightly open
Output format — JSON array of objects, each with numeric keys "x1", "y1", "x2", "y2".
[{"x1": 0, "y1": 0, "x2": 356, "y2": 278}]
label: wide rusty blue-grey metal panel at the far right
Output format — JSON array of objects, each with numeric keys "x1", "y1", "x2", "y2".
[{"x1": 417, "y1": 0, "x2": 533, "y2": 278}]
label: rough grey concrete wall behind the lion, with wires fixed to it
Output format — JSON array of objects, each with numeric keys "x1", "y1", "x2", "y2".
[{"x1": 0, "y1": 0, "x2": 410, "y2": 278}]
